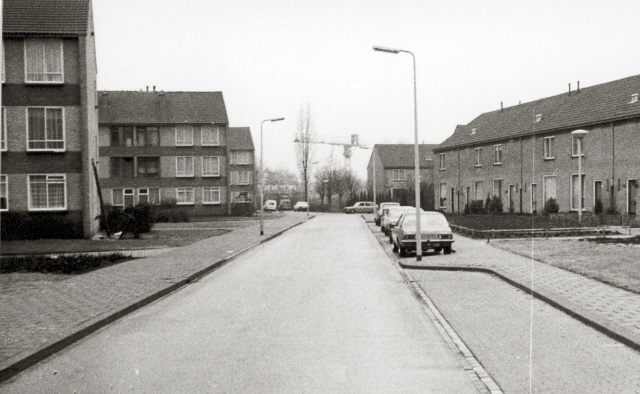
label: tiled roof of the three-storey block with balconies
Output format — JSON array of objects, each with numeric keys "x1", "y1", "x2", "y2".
[{"x1": 98, "y1": 91, "x2": 229, "y2": 124}]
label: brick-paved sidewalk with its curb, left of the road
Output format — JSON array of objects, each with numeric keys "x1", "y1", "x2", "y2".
[{"x1": 0, "y1": 214, "x2": 313, "y2": 382}]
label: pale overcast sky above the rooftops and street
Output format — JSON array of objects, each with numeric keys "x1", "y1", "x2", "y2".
[{"x1": 93, "y1": 0, "x2": 640, "y2": 178}]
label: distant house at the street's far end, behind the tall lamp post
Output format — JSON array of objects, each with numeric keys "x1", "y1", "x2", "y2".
[{"x1": 367, "y1": 144, "x2": 437, "y2": 198}]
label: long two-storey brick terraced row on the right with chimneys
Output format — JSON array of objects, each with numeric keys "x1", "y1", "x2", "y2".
[{"x1": 434, "y1": 76, "x2": 640, "y2": 215}]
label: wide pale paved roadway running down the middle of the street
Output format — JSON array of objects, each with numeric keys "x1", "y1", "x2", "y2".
[{"x1": 0, "y1": 215, "x2": 476, "y2": 393}]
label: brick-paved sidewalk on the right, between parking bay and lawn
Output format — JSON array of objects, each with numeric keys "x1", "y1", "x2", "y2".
[{"x1": 367, "y1": 221, "x2": 640, "y2": 350}]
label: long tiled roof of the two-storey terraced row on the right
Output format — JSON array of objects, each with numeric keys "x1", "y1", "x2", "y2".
[{"x1": 435, "y1": 75, "x2": 640, "y2": 152}]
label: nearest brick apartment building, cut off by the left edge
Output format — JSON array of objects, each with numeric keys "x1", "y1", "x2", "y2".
[{"x1": 0, "y1": 0, "x2": 99, "y2": 237}]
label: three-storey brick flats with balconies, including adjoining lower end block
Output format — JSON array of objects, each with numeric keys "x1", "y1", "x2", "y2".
[{"x1": 99, "y1": 88, "x2": 254, "y2": 215}]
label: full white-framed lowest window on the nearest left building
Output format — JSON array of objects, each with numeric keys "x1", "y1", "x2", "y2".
[{"x1": 28, "y1": 174, "x2": 67, "y2": 211}]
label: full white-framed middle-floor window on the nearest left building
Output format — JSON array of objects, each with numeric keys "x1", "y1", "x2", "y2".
[{"x1": 27, "y1": 107, "x2": 64, "y2": 151}]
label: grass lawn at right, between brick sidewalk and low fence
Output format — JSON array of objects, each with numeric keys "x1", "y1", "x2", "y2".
[{"x1": 491, "y1": 239, "x2": 640, "y2": 294}]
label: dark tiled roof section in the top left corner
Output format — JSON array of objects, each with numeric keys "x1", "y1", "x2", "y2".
[{"x1": 2, "y1": 0, "x2": 91, "y2": 36}]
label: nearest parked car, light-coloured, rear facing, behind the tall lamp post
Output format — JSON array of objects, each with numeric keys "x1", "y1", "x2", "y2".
[{"x1": 391, "y1": 212, "x2": 454, "y2": 257}]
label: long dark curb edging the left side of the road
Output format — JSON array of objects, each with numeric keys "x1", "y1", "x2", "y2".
[{"x1": 0, "y1": 215, "x2": 315, "y2": 383}]
